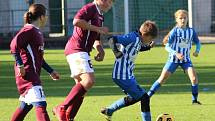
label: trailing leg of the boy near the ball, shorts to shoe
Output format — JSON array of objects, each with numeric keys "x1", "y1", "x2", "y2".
[{"x1": 101, "y1": 79, "x2": 145, "y2": 119}]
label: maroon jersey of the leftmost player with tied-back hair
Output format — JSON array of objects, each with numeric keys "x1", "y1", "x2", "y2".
[{"x1": 10, "y1": 24, "x2": 44, "y2": 94}]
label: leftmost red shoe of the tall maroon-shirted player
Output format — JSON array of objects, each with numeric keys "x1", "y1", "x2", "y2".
[{"x1": 52, "y1": 106, "x2": 67, "y2": 121}]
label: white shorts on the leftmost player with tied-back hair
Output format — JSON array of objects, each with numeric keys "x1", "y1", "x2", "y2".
[{"x1": 19, "y1": 86, "x2": 46, "y2": 104}]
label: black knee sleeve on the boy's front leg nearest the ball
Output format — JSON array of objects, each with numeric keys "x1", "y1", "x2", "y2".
[{"x1": 141, "y1": 93, "x2": 150, "y2": 112}]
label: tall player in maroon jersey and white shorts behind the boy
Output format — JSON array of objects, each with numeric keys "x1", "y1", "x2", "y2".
[{"x1": 53, "y1": 0, "x2": 113, "y2": 121}]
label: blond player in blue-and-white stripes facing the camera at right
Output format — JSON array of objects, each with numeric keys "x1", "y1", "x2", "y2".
[{"x1": 148, "y1": 10, "x2": 201, "y2": 104}]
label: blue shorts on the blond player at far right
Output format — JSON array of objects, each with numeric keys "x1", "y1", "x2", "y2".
[{"x1": 164, "y1": 61, "x2": 193, "y2": 73}]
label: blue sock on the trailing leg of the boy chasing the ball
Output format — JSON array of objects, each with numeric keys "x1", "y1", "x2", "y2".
[{"x1": 108, "y1": 98, "x2": 125, "y2": 115}]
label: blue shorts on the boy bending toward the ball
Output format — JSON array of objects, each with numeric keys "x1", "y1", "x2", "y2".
[{"x1": 113, "y1": 78, "x2": 146, "y2": 100}]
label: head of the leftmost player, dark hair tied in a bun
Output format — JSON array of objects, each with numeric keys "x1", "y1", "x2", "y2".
[{"x1": 24, "y1": 4, "x2": 46, "y2": 24}]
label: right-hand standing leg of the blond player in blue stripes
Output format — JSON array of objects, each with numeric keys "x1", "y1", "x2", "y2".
[{"x1": 182, "y1": 62, "x2": 201, "y2": 105}]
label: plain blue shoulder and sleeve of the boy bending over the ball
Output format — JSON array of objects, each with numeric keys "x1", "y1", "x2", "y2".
[{"x1": 116, "y1": 33, "x2": 136, "y2": 46}]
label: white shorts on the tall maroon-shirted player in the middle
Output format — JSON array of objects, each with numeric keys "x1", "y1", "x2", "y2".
[{"x1": 66, "y1": 52, "x2": 94, "y2": 77}]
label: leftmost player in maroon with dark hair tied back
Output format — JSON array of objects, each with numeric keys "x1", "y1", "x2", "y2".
[{"x1": 10, "y1": 4, "x2": 59, "y2": 121}]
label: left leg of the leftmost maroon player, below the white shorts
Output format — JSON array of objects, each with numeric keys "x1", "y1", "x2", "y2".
[{"x1": 11, "y1": 101, "x2": 33, "y2": 121}]
